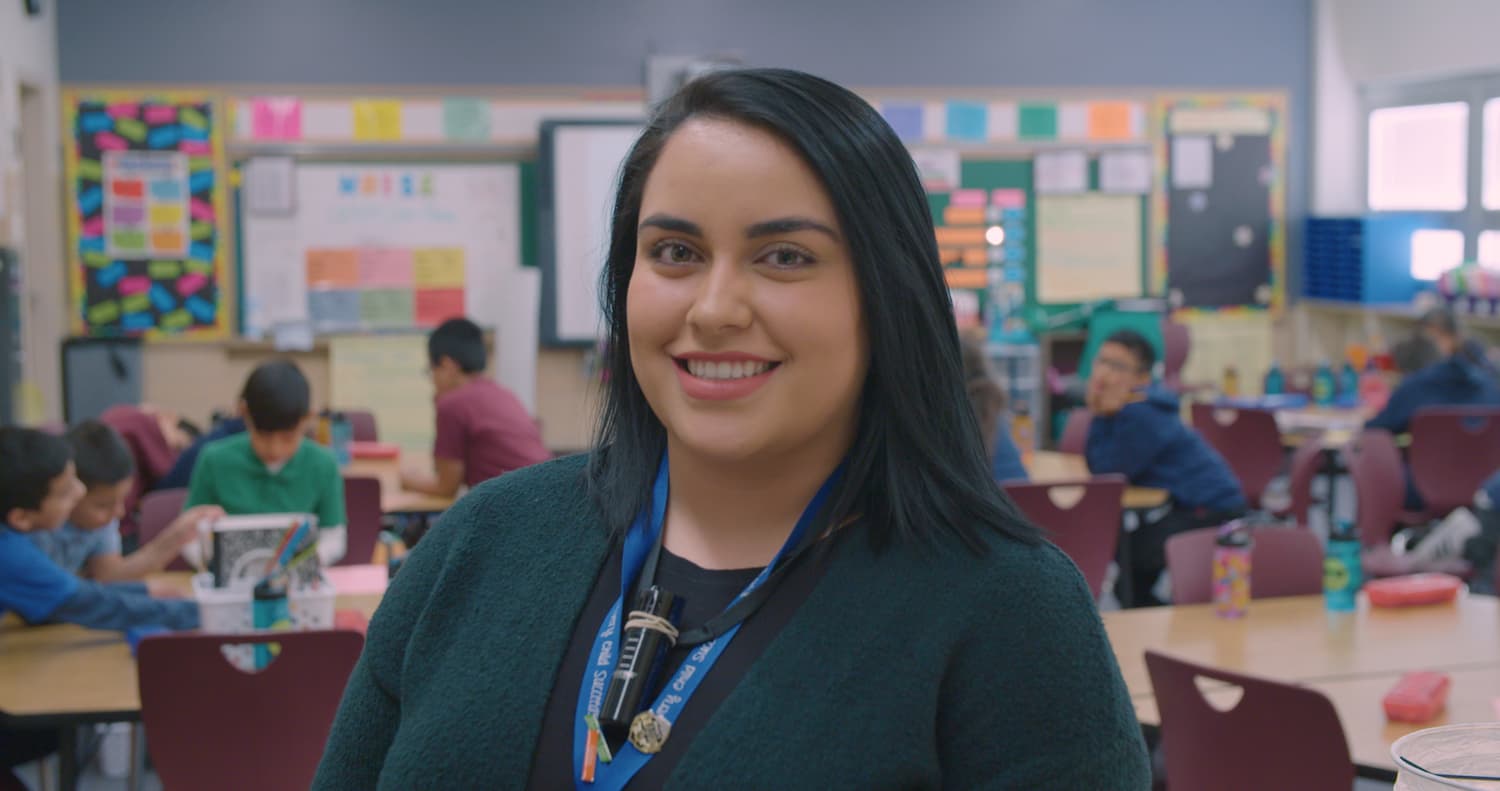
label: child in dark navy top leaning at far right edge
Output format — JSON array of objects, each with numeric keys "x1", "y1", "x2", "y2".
[{"x1": 1365, "y1": 308, "x2": 1500, "y2": 434}]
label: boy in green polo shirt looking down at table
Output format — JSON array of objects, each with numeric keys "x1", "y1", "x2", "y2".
[{"x1": 186, "y1": 360, "x2": 348, "y2": 566}]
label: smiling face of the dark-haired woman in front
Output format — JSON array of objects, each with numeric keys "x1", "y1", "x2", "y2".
[{"x1": 626, "y1": 119, "x2": 869, "y2": 461}]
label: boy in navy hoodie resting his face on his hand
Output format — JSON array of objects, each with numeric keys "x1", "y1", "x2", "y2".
[{"x1": 1085, "y1": 330, "x2": 1245, "y2": 606}]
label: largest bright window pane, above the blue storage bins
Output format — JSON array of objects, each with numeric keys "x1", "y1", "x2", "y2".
[{"x1": 1367, "y1": 102, "x2": 1469, "y2": 211}]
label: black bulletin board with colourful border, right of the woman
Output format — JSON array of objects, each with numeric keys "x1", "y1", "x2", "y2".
[{"x1": 1152, "y1": 95, "x2": 1286, "y2": 311}]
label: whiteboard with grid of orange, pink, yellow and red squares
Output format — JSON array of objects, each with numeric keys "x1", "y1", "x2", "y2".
[{"x1": 243, "y1": 161, "x2": 525, "y2": 338}]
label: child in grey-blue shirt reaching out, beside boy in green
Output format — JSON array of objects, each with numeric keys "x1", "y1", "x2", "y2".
[{"x1": 27, "y1": 420, "x2": 224, "y2": 582}]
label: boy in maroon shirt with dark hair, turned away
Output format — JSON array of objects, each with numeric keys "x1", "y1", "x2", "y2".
[{"x1": 401, "y1": 318, "x2": 552, "y2": 497}]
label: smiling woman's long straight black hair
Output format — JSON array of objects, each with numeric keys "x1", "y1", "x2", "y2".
[{"x1": 588, "y1": 69, "x2": 1041, "y2": 551}]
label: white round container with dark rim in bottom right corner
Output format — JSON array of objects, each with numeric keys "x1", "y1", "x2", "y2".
[{"x1": 1391, "y1": 722, "x2": 1500, "y2": 791}]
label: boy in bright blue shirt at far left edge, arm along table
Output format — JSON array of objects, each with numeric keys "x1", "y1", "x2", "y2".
[{"x1": 0, "y1": 426, "x2": 198, "y2": 630}]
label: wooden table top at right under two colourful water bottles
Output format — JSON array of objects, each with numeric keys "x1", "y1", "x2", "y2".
[{"x1": 1103, "y1": 596, "x2": 1500, "y2": 696}]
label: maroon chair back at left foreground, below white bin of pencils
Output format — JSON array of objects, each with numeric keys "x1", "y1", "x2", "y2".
[{"x1": 137, "y1": 630, "x2": 365, "y2": 791}]
